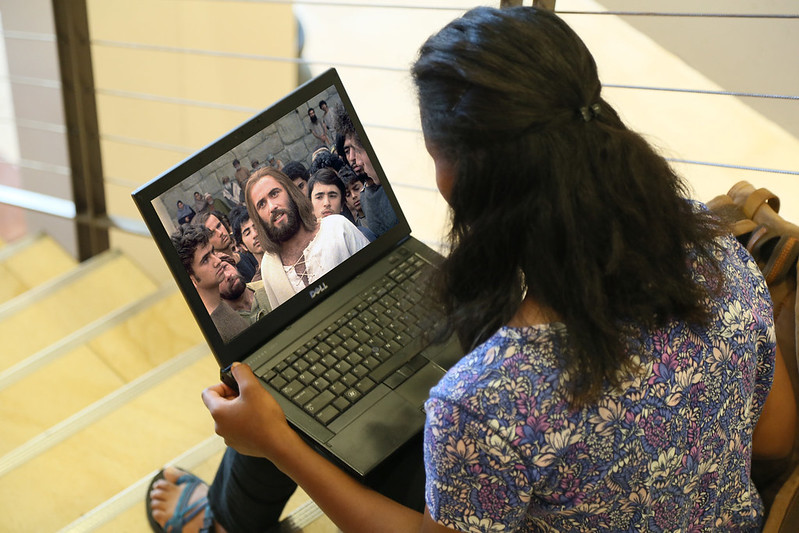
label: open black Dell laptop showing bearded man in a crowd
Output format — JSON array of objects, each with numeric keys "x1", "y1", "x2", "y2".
[{"x1": 133, "y1": 69, "x2": 462, "y2": 477}]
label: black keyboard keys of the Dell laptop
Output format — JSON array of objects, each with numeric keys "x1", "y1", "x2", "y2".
[{"x1": 256, "y1": 249, "x2": 435, "y2": 425}]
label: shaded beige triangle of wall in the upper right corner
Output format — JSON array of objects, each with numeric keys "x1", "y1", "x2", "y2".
[{"x1": 599, "y1": 0, "x2": 799, "y2": 137}]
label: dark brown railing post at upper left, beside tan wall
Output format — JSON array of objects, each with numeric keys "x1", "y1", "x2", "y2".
[{"x1": 53, "y1": 0, "x2": 109, "y2": 261}]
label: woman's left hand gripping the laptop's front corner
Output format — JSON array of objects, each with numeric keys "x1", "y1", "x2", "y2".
[{"x1": 203, "y1": 363, "x2": 298, "y2": 462}]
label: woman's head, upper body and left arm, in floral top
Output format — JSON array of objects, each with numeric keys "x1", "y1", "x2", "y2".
[{"x1": 152, "y1": 7, "x2": 793, "y2": 531}]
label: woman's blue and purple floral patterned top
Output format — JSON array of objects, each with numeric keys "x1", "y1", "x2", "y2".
[{"x1": 425, "y1": 238, "x2": 775, "y2": 532}]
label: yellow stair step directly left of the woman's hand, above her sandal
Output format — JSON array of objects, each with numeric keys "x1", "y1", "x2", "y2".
[{"x1": 0, "y1": 345, "x2": 218, "y2": 531}]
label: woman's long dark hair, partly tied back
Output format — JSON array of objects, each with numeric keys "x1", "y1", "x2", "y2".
[{"x1": 413, "y1": 7, "x2": 720, "y2": 404}]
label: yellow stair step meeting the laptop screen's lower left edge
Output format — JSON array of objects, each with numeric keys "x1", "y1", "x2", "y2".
[{"x1": 0, "y1": 288, "x2": 201, "y2": 455}]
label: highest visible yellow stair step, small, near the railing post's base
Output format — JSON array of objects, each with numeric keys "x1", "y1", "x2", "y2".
[{"x1": 0, "y1": 235, "x2": 77, "y2": 303}]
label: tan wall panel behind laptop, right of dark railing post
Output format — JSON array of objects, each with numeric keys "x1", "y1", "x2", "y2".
[{"x1": 88, "y1": 0, "x2": 297, "y2": 279}]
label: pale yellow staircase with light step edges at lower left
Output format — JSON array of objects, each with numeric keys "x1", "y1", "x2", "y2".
[{"x1": 0, "y1": 235, "x2": 337, "y2": 533}]
